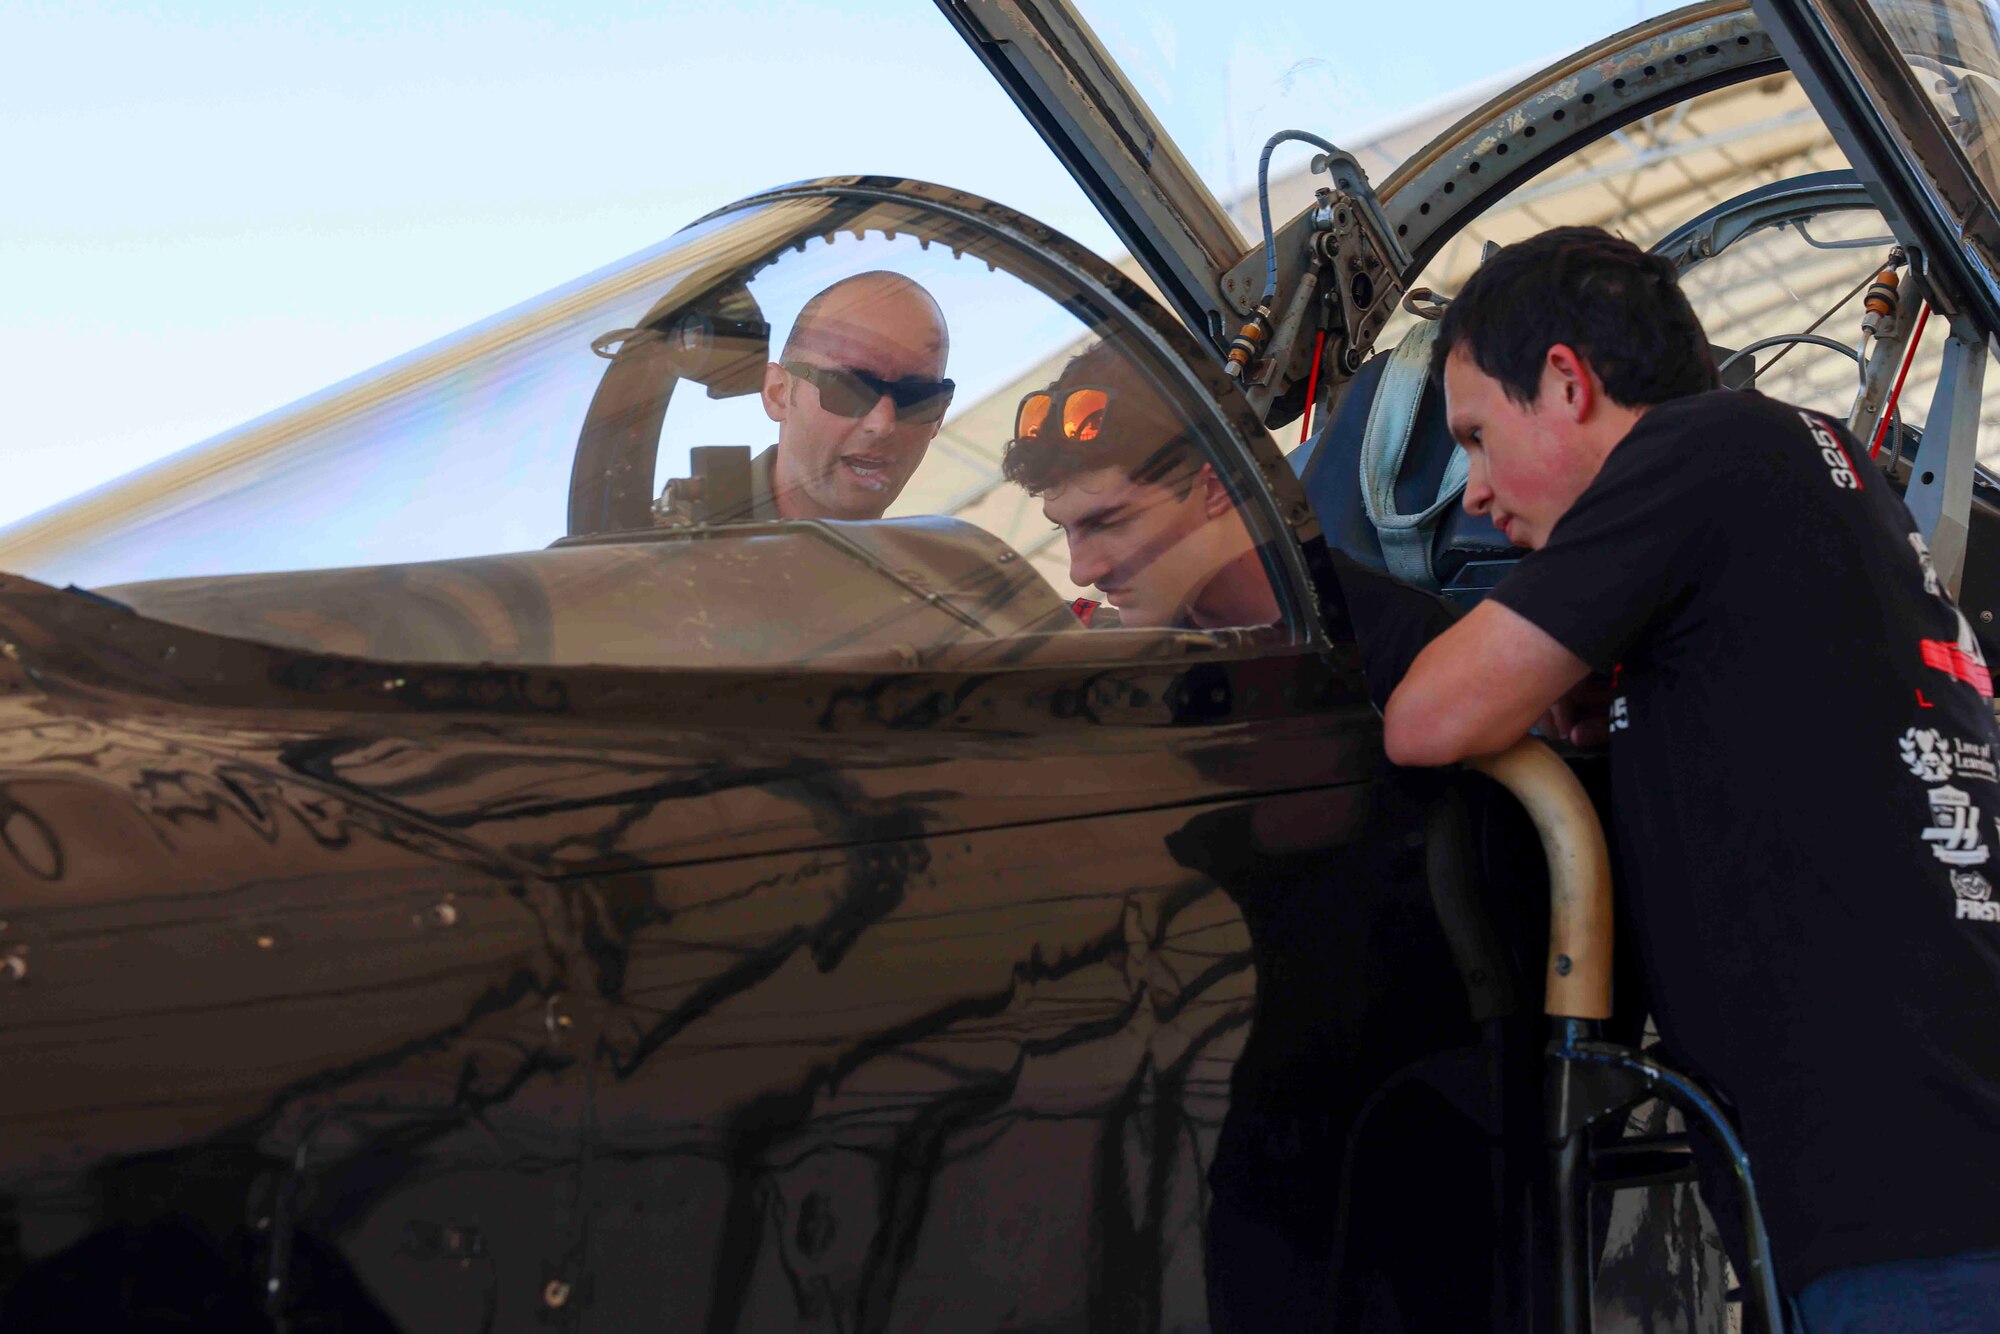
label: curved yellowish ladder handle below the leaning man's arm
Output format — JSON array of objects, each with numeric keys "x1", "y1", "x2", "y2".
[{"x1": 1466, "y1": 736, "x2": 1612, "y2": 1020}]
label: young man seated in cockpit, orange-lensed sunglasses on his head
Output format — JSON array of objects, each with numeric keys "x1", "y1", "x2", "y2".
[{"x1": 1000, "y1": 344, "x2": 1278, "y2": 630}]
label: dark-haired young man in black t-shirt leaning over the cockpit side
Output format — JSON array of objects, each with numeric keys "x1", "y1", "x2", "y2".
[{"x1": 1386, "y1": 228, "x2": 2000, "y2": 1334}]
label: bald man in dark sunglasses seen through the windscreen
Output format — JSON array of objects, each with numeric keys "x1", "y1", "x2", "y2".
[{"x1": 750, "y1": 270, "x2": 952, "y2": 518}]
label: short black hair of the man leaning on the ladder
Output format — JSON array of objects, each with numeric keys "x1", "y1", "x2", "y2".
[{"x1": 1430, "y1": 226, "x2": 1720, "y2": 408}]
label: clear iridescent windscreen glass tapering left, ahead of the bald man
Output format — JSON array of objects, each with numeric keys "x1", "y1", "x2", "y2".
[{"x1": 0, "y1": 204, "x2": 812, "y2": 588}]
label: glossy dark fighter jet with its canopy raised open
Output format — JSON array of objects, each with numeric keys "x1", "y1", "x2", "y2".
[{"x1": 0, "y1": 0, "x2": 2000, "y2": 1332}]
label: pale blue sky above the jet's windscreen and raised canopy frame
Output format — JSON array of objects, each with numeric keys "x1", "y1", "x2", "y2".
[{"x1": 0, "y1": 0, "x2": 1666, "y2": 524}]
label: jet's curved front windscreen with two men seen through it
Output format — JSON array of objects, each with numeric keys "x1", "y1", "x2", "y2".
[{"x1": 6, "y1": 180, "x2": 1308, "y2": 670}]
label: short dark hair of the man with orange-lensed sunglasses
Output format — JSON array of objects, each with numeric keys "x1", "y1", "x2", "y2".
[{"x1": 1000, "y1": 342, "x2": 1206, "y2": 496}]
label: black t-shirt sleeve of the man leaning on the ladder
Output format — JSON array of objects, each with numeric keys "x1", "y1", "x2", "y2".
[{"x1": 1490, "y1": 426, "x2": 1734, "y2": 672}]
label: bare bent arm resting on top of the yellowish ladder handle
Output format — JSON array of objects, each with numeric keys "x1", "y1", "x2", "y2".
[{"x1": 1382, "y1": 598, "x2": 1590, "y2": 764}]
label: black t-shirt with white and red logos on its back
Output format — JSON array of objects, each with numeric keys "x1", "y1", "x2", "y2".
[{"x1": 1492, "y1": 392, "x2": 2000, "y2": 1292}]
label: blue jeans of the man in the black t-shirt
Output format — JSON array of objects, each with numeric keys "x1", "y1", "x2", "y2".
[{"x1": 1794, "y1": 1250, "x2": 2000, "y2": 1334}]
